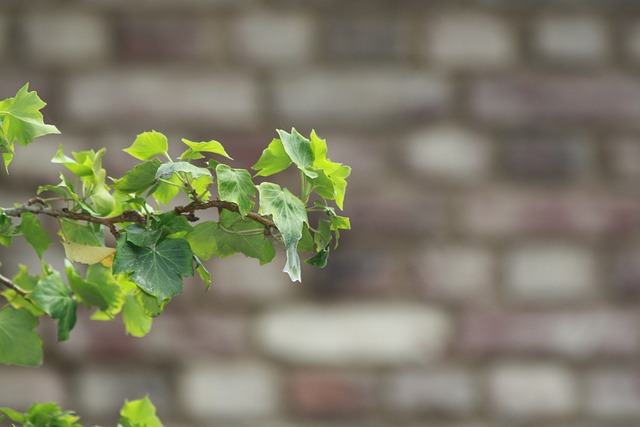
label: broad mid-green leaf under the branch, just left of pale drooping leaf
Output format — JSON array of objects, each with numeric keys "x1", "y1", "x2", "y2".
[{"x1": 186, "y1": 210, "x2": 275, "y2": 264}]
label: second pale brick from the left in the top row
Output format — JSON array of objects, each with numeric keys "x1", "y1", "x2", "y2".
[{"x1": 233, "y1": 12, "x2": 315, "y2": 67}]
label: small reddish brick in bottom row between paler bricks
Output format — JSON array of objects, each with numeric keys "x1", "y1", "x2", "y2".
[{"x1": 288, "y1": 371, "x2": 375, "y2": 417}]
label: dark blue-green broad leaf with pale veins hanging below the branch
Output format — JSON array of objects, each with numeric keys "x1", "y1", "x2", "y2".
[{"x1": 113, "y1": 236, "x2": 193, "y2": 302}]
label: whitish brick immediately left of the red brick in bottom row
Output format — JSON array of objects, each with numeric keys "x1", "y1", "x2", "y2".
[{"x1": 178, "y1": 361, "x2": 281, "y2": 419}]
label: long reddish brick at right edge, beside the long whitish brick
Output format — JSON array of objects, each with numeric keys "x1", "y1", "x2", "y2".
[{"x1": 458, "y1": 309, "x2": 640, "y2": 359}]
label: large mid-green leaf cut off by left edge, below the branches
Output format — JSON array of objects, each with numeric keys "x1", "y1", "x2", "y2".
[{"x1": 0, "y1": 307, "x2": 42, "y2": 368}]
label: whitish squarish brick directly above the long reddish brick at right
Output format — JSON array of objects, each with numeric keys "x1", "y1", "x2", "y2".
[{"x1": 505, "y1": 243, "x2": 596, "y2": 304}]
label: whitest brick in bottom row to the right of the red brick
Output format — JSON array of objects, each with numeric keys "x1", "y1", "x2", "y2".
[{"x1": 489, "y1": 363, "x2": 578, "y2": 421}]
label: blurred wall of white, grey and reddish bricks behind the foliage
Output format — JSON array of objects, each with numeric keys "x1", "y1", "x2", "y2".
[{"x1": 0, "y1": 0, "x2": 640, "y2": 427}]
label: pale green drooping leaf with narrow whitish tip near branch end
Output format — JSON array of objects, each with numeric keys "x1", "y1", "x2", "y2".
[{"x1": 258, "y1": 182, "x2": 309, "y2": 281}]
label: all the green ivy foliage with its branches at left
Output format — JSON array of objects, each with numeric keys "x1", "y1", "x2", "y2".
[{"x1": 0, "y1": 85, "x2": 351, "y2": 427}]
